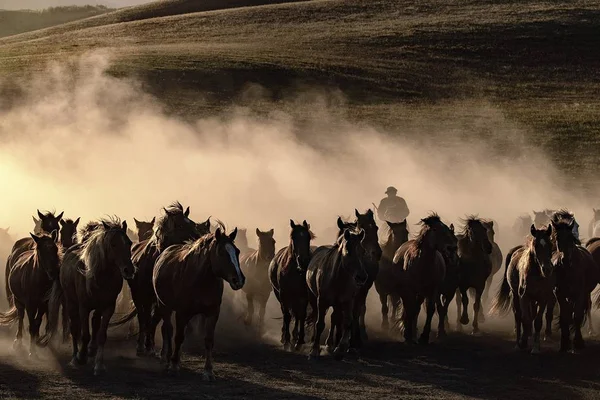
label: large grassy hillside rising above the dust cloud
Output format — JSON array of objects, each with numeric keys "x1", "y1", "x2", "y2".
[{"x1": 0, "y1": 0, "x2": 600, "y2": 174}]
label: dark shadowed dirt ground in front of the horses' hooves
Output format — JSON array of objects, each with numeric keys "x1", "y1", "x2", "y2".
[{"x1": 0, "y1": 310, "x2": 600, "y2": 400}]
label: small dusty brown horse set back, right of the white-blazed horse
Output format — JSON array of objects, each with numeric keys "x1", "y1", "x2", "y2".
[{"x1": 240, "y1": 228, "x2": 275, "y2": 333}]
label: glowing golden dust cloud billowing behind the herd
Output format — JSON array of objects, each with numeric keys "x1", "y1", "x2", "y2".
[{"x1": 0, "y1": 52, "x2": 593, "y2": 350}]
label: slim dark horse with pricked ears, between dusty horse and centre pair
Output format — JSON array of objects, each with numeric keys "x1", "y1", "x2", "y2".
[{"x1": 268, "y1": 220, "x2": 315, "y2": 351}]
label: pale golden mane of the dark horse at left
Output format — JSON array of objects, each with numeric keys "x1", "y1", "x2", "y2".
[{"x1": 79, "y1": 216, "x2": 122, "y2": 287}]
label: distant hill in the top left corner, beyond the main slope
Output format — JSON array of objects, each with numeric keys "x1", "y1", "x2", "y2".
[{"x1": 0, "y1": 6, "x2": 112, "y2": 37}]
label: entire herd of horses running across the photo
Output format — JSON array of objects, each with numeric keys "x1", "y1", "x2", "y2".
[{"x1": 0, "y1": 202, "x2": 600, "y2": 380}]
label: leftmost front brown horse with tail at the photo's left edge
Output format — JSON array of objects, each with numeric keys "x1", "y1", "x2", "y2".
[{"x1": 0, "y1": 230, "x2": 60, "y2": 356}]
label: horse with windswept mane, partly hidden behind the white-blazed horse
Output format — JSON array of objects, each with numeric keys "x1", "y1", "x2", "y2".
[{"x1": 110, "y1": 202, "x2": 200, "y2": 356}]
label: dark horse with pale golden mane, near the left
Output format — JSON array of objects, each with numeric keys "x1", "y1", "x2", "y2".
[{"x1": 48, "y1": 217, "x2": 135, "y2": 375}]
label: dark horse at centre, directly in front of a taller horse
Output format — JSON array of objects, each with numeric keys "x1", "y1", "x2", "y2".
[{"x1": 306, "y1": 229, "x2": 372, "y2": 360}]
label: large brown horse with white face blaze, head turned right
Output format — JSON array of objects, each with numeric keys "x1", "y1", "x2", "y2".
[{"x1": 152, "y1": 228, "x2": 246, "y2": 381}]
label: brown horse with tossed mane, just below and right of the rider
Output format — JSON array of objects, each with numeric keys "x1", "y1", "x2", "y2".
[{"x1": 394, "y1": 224, "x2": 446, "y2": 344}]
